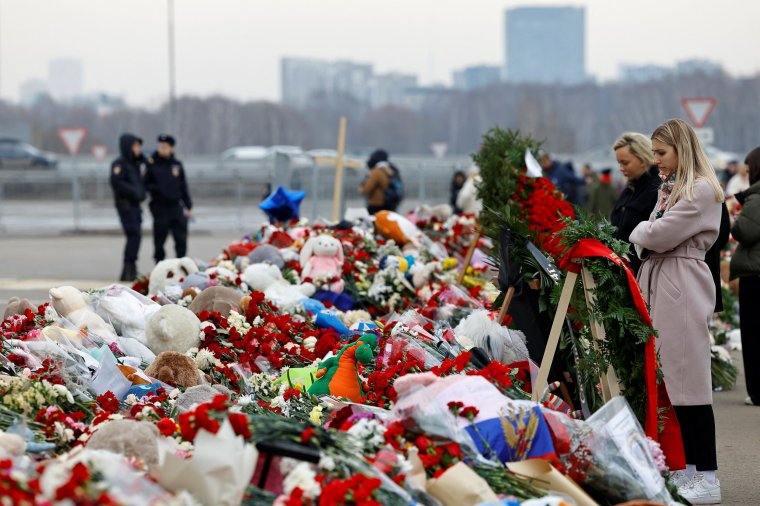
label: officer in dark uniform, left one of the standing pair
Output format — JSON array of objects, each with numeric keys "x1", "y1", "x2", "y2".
[{"x1": 110, "y1": 134, "x2": 145, "y2": 281}]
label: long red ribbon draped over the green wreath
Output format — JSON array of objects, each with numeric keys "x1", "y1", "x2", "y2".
[{"x1": 559, "y1": 239, "x2": 686, "y2": 470}]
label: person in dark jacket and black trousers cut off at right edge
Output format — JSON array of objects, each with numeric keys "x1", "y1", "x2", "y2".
[{"x1": 730, "y1": 147, "x2": 760, "y2": 406}]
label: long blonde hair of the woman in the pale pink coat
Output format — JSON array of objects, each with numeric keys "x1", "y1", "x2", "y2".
[{"x1": 652, "y1": 119, "x2": 725, "y2": 207}]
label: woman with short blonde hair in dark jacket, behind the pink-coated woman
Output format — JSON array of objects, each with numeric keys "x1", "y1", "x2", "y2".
[{"x1": 610, "y1": 132, "x2": 662, "y2": 274}]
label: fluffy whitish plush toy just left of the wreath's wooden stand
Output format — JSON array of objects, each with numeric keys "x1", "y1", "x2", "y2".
[{"x1": 454, "y1": 309, "x2": 528, "y2": 364}]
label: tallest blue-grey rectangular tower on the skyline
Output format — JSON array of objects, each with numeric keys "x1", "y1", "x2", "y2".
[{"x1": 505, "y1": 7, "x2": 586, "y2": 84}]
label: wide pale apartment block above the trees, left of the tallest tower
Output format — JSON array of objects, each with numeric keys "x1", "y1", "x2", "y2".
[{"x1": 280, "y1": 58, "x2": 373, "y2": 107}]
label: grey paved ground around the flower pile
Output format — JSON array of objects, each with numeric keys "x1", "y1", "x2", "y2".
[{"x1": 0, "y1": 231, "x2": 760, "y2": 506}]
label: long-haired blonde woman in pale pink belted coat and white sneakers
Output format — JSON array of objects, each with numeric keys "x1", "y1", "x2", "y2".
[{"x1": 630, "y1": 119, "x2": 724, "y2": 504}]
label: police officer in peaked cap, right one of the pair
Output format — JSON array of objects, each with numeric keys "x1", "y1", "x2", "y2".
[{"x1": 145, "y1": 134, "x2": 193, "y2": 262}]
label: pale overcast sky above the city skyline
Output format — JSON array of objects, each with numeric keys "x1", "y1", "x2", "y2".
[{"x1": 0, "y1": 0, "x2": 760, "y2": 106}]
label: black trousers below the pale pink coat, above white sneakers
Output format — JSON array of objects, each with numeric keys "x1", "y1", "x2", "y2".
[{"x1": 673, "y1": 404, "x2": 718, "y2": 471}]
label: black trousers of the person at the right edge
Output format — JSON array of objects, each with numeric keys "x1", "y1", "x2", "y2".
[{"x1": 739, "y1": 276, "x2": 760, "y2": 406}]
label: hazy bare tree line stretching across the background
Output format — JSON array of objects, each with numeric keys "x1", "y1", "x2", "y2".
[{"x1": 0, "y1": 69, "x2": 760, "y2": 154}]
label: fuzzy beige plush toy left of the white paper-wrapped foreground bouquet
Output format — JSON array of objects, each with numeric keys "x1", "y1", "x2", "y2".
[{"x1": 87, "y1": 420, "x2": 159, "y2": 466}]
